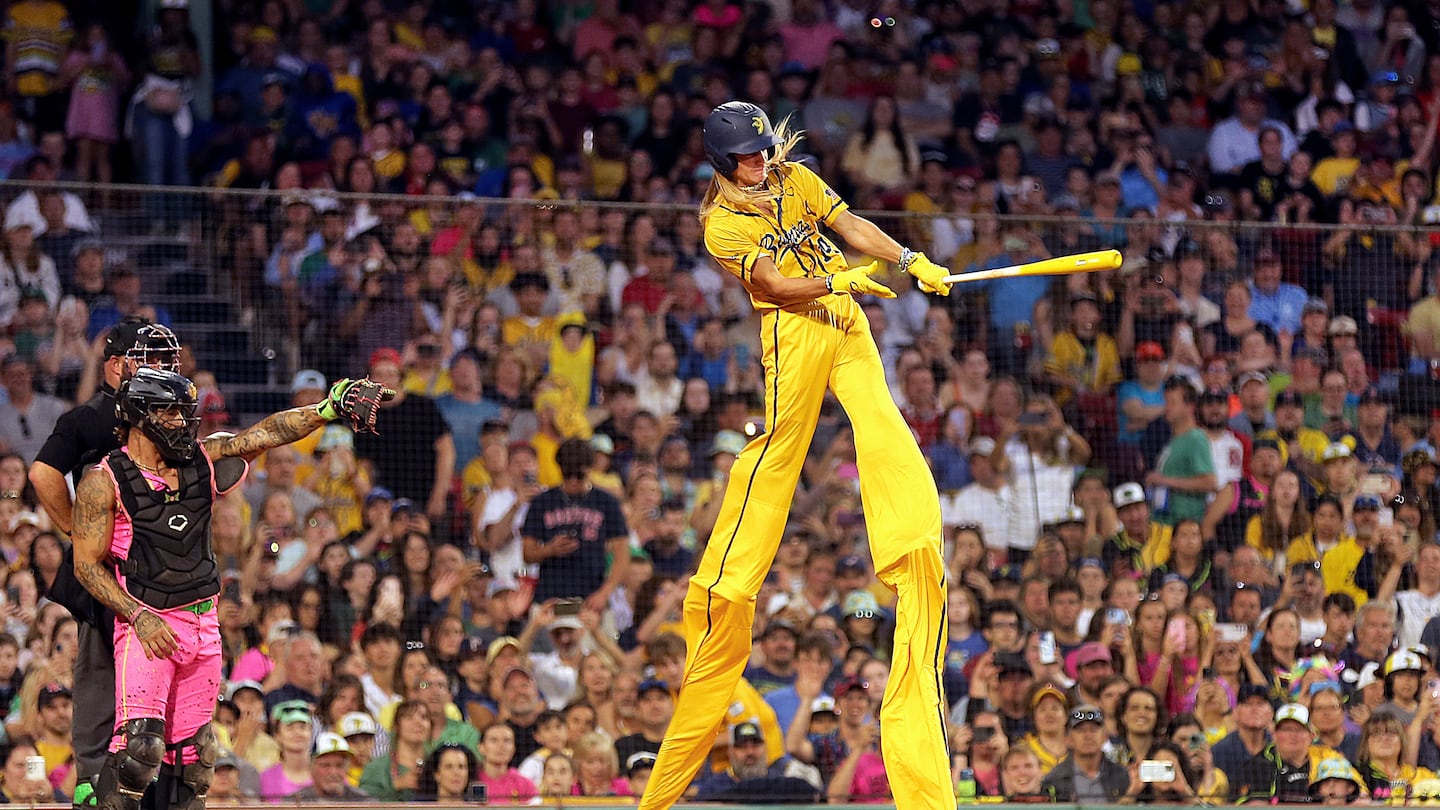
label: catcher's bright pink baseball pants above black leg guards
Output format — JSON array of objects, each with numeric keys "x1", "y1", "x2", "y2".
[{"x1": 109, "y1": 604, "x2": 222, "y2": 760}]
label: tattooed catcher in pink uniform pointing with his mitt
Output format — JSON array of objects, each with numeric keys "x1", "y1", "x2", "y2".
[{"x1": 72, "y1": 368, "x2": 395, "y2": 810}]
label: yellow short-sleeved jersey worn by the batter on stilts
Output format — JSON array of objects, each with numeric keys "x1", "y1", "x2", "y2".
[{"x1": 706, "y1": 163, "x2": 850, "y2": 310}]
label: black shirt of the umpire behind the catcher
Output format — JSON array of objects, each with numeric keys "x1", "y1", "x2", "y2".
[{"x1": 35, "y1": 383, "x2": 120, "y2": 625}]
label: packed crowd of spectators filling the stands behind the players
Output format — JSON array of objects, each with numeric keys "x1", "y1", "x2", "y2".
[{"x1": 11, "y1": 0, "x2": 1440, "y2": 803}]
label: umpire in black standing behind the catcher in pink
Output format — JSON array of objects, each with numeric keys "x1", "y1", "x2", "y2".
[{"x1": 30, "y1": 316, "x2": 180, "y2": 807}]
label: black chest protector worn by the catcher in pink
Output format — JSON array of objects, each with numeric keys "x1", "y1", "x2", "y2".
[{"x1": 105, "y1": 450, "x2": 220, "y2": 610}]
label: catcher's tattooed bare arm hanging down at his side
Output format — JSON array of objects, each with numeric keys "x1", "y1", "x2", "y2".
[{"x1": 71, "y1": 470, "x2": 179, "y2": 659}]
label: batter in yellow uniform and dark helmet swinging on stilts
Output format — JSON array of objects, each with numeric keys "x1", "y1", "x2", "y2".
[{"x1": 639, "y1": 101, "x2": 955, "y2": 810}]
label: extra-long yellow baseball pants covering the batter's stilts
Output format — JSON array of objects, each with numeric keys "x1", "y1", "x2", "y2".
[{"x1": 639, "y1": 295, "x2": 955, "y2": 810}]
